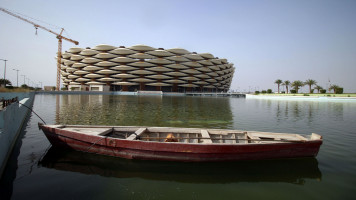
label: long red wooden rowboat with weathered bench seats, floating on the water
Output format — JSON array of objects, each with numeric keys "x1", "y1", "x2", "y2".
[{"x1": 39, "y1": 124, "x2": 322, "y2": 162}]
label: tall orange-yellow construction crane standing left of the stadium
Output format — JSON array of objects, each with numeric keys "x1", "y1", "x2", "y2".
[{"x1": 0, "y1": 7, "x2": 79, "y2": 91}]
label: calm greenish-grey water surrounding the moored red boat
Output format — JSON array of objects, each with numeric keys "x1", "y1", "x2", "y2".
[{"x1": 0, "y1": 95, "x2": 356, "y2": 199}]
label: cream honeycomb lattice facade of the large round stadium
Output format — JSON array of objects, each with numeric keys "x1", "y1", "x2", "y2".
[{"x1": 61, "y1": 45, "x2": 235, "y2": 92}]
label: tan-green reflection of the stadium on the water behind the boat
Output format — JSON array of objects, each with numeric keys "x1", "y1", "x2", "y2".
[{"x1": 56, "y1": 95, "x2": 233, "y2": 128}]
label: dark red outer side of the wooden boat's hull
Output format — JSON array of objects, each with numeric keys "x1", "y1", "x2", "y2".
[{"x1": 41, "y1": 126, "x2": 322, "y2": 162}]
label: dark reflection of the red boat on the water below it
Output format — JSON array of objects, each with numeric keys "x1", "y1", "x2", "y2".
[{"x1": 38, "y1": 146, "x2": 322, "y2": 185}]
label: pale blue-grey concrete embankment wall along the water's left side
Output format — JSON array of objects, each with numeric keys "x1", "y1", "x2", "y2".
[{"x1": 0, "y1": 92, "x2": 35, "y2": 177}]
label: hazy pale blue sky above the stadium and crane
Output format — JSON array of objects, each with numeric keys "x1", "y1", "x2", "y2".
[{"x1": 0, "y1": 0, "x2": 356, "y2": 92}]
